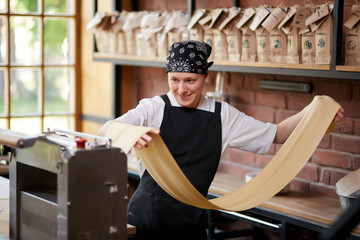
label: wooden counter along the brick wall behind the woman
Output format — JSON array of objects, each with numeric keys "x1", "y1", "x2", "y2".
[{"x1": 128, "y1": 160, "x2": 360, "y2": 236}]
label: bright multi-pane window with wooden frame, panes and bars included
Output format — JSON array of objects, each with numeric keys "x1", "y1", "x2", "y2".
[{"x1": 0, "y1": 0, "x2": 79, "y2": 133}]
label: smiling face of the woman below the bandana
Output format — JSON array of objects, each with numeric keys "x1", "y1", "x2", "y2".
[{"x1": 168, "y1": 72, "x2": 208, "y2": 108}]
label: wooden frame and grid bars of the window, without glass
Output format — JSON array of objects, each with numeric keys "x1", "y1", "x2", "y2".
[{"x1": 0, "y1": 0, "x2": 81, "y2": 131}]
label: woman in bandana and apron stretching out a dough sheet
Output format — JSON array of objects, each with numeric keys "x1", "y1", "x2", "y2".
[{"x1": 100, "y1": 40, "x2": 343, "y2": 240}]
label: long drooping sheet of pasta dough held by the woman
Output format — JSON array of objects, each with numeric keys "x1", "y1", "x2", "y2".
[{"x1": 105, "y1": 96, "x2": 340, "y2": 211}]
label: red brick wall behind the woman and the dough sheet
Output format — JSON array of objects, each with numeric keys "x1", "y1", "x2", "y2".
[{"x1": 135, "y1": 0, "x2": 360, "y2": 198}]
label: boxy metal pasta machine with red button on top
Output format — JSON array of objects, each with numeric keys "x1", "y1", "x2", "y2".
[{"x1": 0, "y1": 129, "x2": 127, "y2": 240}]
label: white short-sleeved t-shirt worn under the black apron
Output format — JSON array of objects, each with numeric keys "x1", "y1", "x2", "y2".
[{"x1": 116, "y1": 91, "x2": 277, "y2": 173}]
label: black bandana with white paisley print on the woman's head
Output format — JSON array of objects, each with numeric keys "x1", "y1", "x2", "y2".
[{"x1": 166, "y1": 40, "x2": 213, "y2": 74}]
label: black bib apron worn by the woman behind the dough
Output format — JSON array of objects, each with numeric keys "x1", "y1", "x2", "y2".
[{"x1": 128, "y1": 95, "x2": 221, "y2": 240}]
